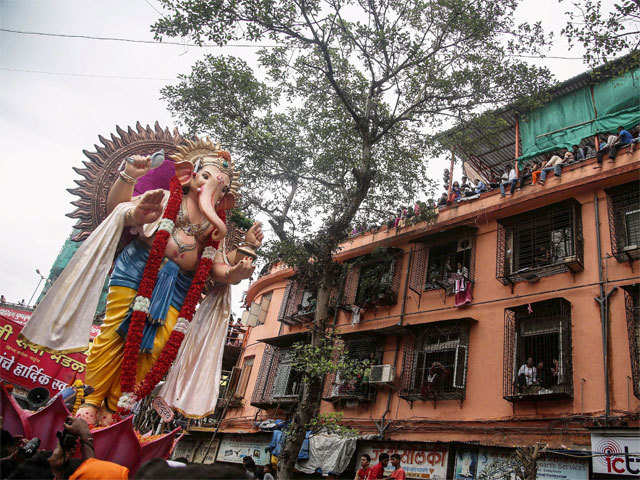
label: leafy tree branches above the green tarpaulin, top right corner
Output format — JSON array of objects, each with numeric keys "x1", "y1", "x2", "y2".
[{"x1": 562, "y1": 0, "x2": 640, "y2": 68}]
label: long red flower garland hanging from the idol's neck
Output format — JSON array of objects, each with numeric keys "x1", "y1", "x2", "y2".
[{"x1": 120, "y1": 177, "x2": 226, "y2": 411}]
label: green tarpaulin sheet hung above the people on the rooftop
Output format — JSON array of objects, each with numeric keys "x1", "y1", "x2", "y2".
[{"x1": 518, "y1": 68, "x2": 640, "y2": 166}]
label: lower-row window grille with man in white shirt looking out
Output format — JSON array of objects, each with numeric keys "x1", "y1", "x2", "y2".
[{"x1": 503, "y1": 299, "x2": 573, "y2": 401}]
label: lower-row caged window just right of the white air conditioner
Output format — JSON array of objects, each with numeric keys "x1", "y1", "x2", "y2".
[{"x1": 400, "y1": 321, "x2": 469, "y2": 401}]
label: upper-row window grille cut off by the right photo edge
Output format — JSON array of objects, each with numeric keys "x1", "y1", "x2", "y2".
[{"x1": 607, "y1": 181, "x2": 640, "y2": 262}]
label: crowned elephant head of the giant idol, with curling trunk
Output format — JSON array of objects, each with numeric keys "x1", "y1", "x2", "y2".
[{"x1": 173, "y1": 138, "x2": 240, "y2": 244}]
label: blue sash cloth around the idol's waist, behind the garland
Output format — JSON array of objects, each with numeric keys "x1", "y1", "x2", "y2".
[{"x1": 109, "y1": 240, "x2": 193, "y2": 353}]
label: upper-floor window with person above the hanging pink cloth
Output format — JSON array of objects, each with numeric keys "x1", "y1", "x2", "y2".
[{"x1": 425, "y1": 238, "x2": 472, "y2": 291}]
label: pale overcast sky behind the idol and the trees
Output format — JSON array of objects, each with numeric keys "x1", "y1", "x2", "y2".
[{"x1": 0, "y1": 0, "x2": 613, "y2": 310}]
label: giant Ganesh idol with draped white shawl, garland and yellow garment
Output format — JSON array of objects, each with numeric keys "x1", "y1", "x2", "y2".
[{"x1": 22, "y1": 138, "x2": 263, "y2": 425}]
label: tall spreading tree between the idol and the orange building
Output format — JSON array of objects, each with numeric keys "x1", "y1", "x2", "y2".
[{"x1": 152, "y1": 0, "x2": 550, "y2": 479}]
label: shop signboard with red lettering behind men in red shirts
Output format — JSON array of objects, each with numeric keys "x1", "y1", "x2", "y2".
[{"x1": 356, "y1": 444, "x2": 448, "y2": 480}]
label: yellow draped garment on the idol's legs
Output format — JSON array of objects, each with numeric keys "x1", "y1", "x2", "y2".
[{"x1": 84, "y1": 286, "x2": 179, "y2": 412}]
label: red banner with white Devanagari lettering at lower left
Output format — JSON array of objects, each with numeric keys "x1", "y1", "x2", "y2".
[{"x1": 0, "y1": 314, "x2": 86, "y2": 396}]
